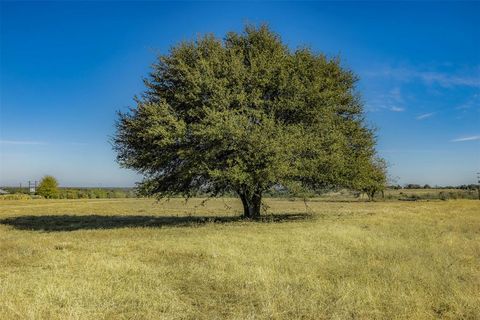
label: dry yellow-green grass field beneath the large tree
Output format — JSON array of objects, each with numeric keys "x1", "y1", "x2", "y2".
[{"x1": 0, "y1": 199, "x2": 480, "y2": 319}]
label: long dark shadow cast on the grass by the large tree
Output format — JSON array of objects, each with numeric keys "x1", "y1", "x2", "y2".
[{"x1": 0, "y1": 213, "x2": 311, "y2": 232}]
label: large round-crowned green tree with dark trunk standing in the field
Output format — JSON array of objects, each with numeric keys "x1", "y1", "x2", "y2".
[{"x1": 113, "y1": 25, "x2": 384, "y2": 218}]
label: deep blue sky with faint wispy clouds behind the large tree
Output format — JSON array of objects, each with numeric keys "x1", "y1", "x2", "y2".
[{"x1": 0, "y1": 2, "x2": 480, "y2": 186}]
